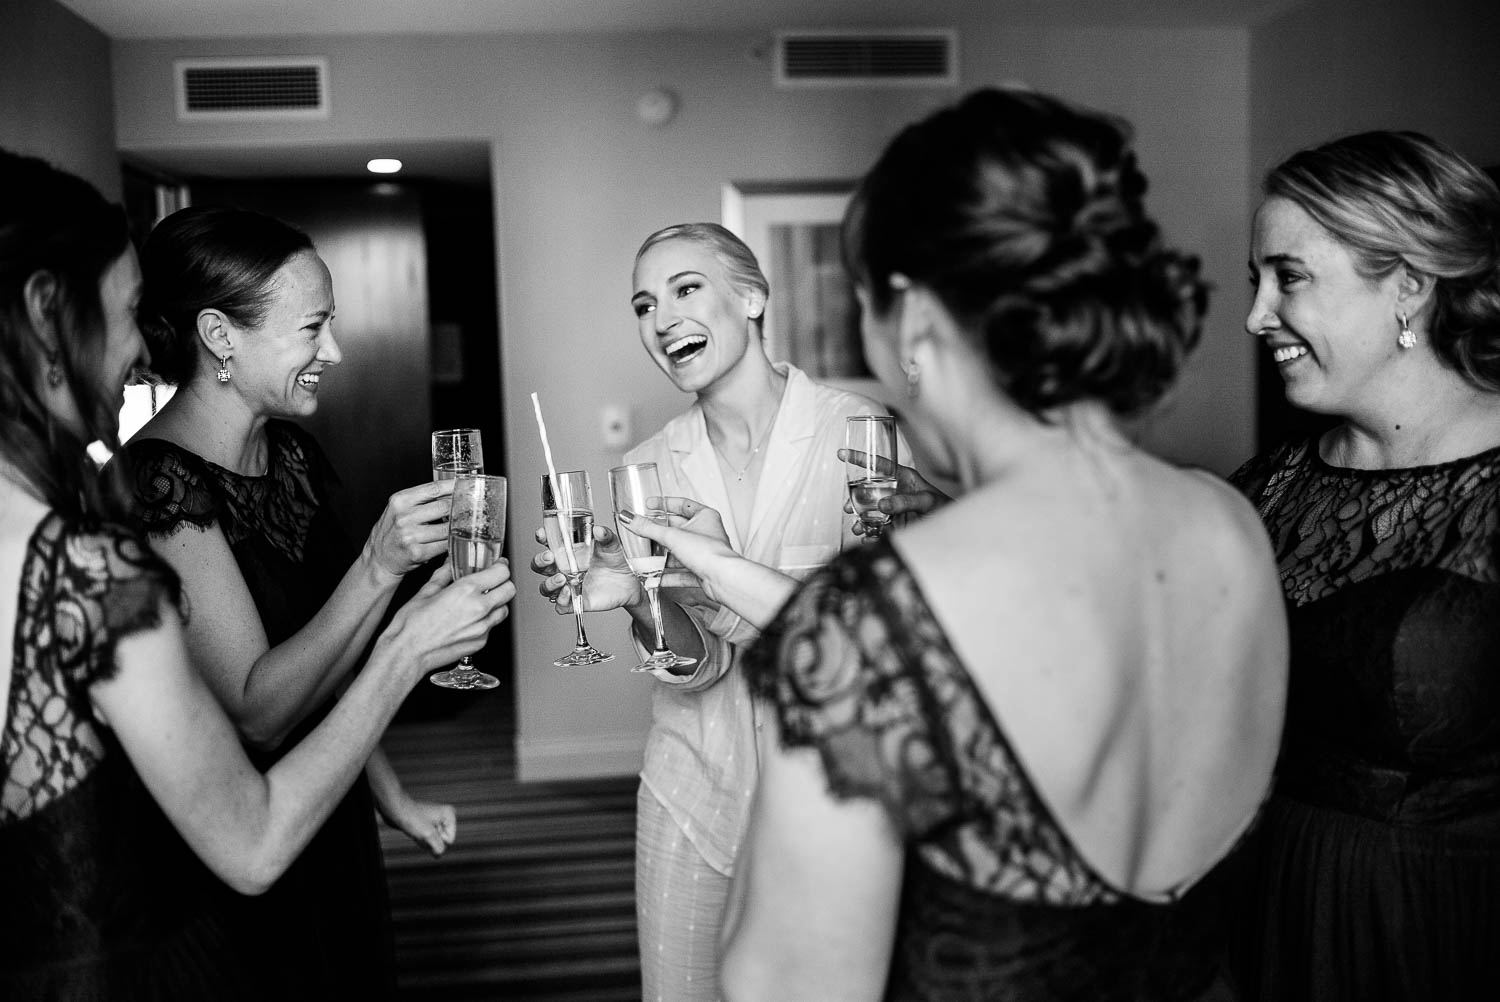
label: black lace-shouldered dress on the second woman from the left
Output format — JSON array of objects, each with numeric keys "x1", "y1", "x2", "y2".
[{"x1": 116, "y1": 420, "x2": 395, "y2": 1002}]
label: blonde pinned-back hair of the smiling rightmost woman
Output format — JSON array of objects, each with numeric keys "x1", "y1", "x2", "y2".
[{"x1": 1265, "y1": 132, "x2": 1500, "y2": 392}]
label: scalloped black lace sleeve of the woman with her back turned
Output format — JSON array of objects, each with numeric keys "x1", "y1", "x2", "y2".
[{"x1": 746, "y1": 548, "x2": 959, "y2": 840}]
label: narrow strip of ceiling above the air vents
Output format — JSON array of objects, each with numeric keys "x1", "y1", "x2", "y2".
[{"x1": 60, "y1": 0, "x2": 1302, "y2": 39}]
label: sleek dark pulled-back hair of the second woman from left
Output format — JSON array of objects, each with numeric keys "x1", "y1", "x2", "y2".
[{"x1": 140, "y1": 206, "x2": 314, "y2": 384}]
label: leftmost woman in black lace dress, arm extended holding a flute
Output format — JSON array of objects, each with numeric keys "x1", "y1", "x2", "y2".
[{"x1": 0, "y1": 152, "x2": 515, "y2": 1002}]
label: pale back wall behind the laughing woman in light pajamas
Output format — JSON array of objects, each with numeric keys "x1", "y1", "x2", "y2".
[{"x1": 114, "y1": 21, "x2": 1253, "y2": 779}]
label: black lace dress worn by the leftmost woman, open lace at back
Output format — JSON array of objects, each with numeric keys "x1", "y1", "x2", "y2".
[{"x1": 0, "y1": 513, "x2": 243, "y2": 999}]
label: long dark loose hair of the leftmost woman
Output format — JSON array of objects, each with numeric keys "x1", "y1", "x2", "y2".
[{"x1": 0, "y1": 150, "x2": 131, "y2": 518}]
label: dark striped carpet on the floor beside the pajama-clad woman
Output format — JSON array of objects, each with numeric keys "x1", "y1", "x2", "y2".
[{"x1": 381, "y1": 680, "x2": 641, "y2": 1002}]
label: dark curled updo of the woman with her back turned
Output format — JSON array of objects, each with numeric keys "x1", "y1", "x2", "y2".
[{"x1": 843, "y1": 90, "x2": 1208, "y2": 414}]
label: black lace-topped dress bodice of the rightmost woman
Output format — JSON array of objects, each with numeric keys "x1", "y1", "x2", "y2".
[{"x1": 1233, "y1": 441, "x2": 1500, "y2": 836}]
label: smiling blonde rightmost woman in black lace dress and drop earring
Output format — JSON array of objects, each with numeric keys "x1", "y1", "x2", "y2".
[{"x1": 1235, "y1": 132, "x2": 1500, "y2": 1002}]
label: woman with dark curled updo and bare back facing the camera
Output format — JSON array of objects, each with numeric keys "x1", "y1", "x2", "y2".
[{"x1": 722, "y1": 90, "x2": 1286, "y2": 1001}]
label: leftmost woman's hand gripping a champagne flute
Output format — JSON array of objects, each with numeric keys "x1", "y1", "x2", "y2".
[{"x1": 380, "y1": 560, "x2": 516, "y2": 675}]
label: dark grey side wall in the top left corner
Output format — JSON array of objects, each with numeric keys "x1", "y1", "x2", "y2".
[{"x1": 0, "y1": 0, "x2": 120, "y2": 201}]
